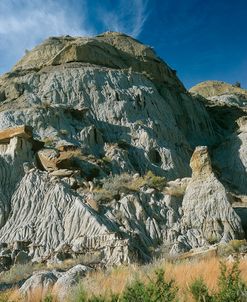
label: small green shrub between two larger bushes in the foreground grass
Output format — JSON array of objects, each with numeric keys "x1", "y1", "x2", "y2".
[{"x1": 189, "y1": 278, "x2": 213, "y2": 302}]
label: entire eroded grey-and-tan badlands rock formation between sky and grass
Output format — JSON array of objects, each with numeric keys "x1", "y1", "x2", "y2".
[{"x1": 0, "y1": 32, "x2": 247, "y2": 274}]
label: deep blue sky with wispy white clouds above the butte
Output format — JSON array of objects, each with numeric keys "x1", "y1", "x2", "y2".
[{"x1": 0, "y1": 0, "x2": 247, "y2": 88}]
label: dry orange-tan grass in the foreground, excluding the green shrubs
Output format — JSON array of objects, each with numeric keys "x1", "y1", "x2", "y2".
[{"x1": 0, "y1": 257, "x2": 247, "y2": 302}]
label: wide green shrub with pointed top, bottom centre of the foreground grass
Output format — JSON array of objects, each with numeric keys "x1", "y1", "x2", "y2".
[{"x1": 119, "y1": 270, "x2": 177, "y2": 302}]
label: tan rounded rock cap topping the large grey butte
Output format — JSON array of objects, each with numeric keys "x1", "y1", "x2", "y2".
[{"x1": 14, "y1": 32, "x2": 185, "y2": 92}]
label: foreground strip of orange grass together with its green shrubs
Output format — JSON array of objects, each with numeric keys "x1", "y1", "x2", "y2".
[{"x1": 0, "y1": 258, "x2": 247, "y2": 302}]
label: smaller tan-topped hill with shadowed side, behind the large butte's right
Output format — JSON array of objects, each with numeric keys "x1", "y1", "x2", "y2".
[{"x1": 190, "y1": 81, "x2": 247, "y2": 195}]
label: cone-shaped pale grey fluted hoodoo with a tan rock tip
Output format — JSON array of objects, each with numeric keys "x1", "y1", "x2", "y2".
[{"x1": 182, "y1": 147, "x2": 244, "y2": 244}]
